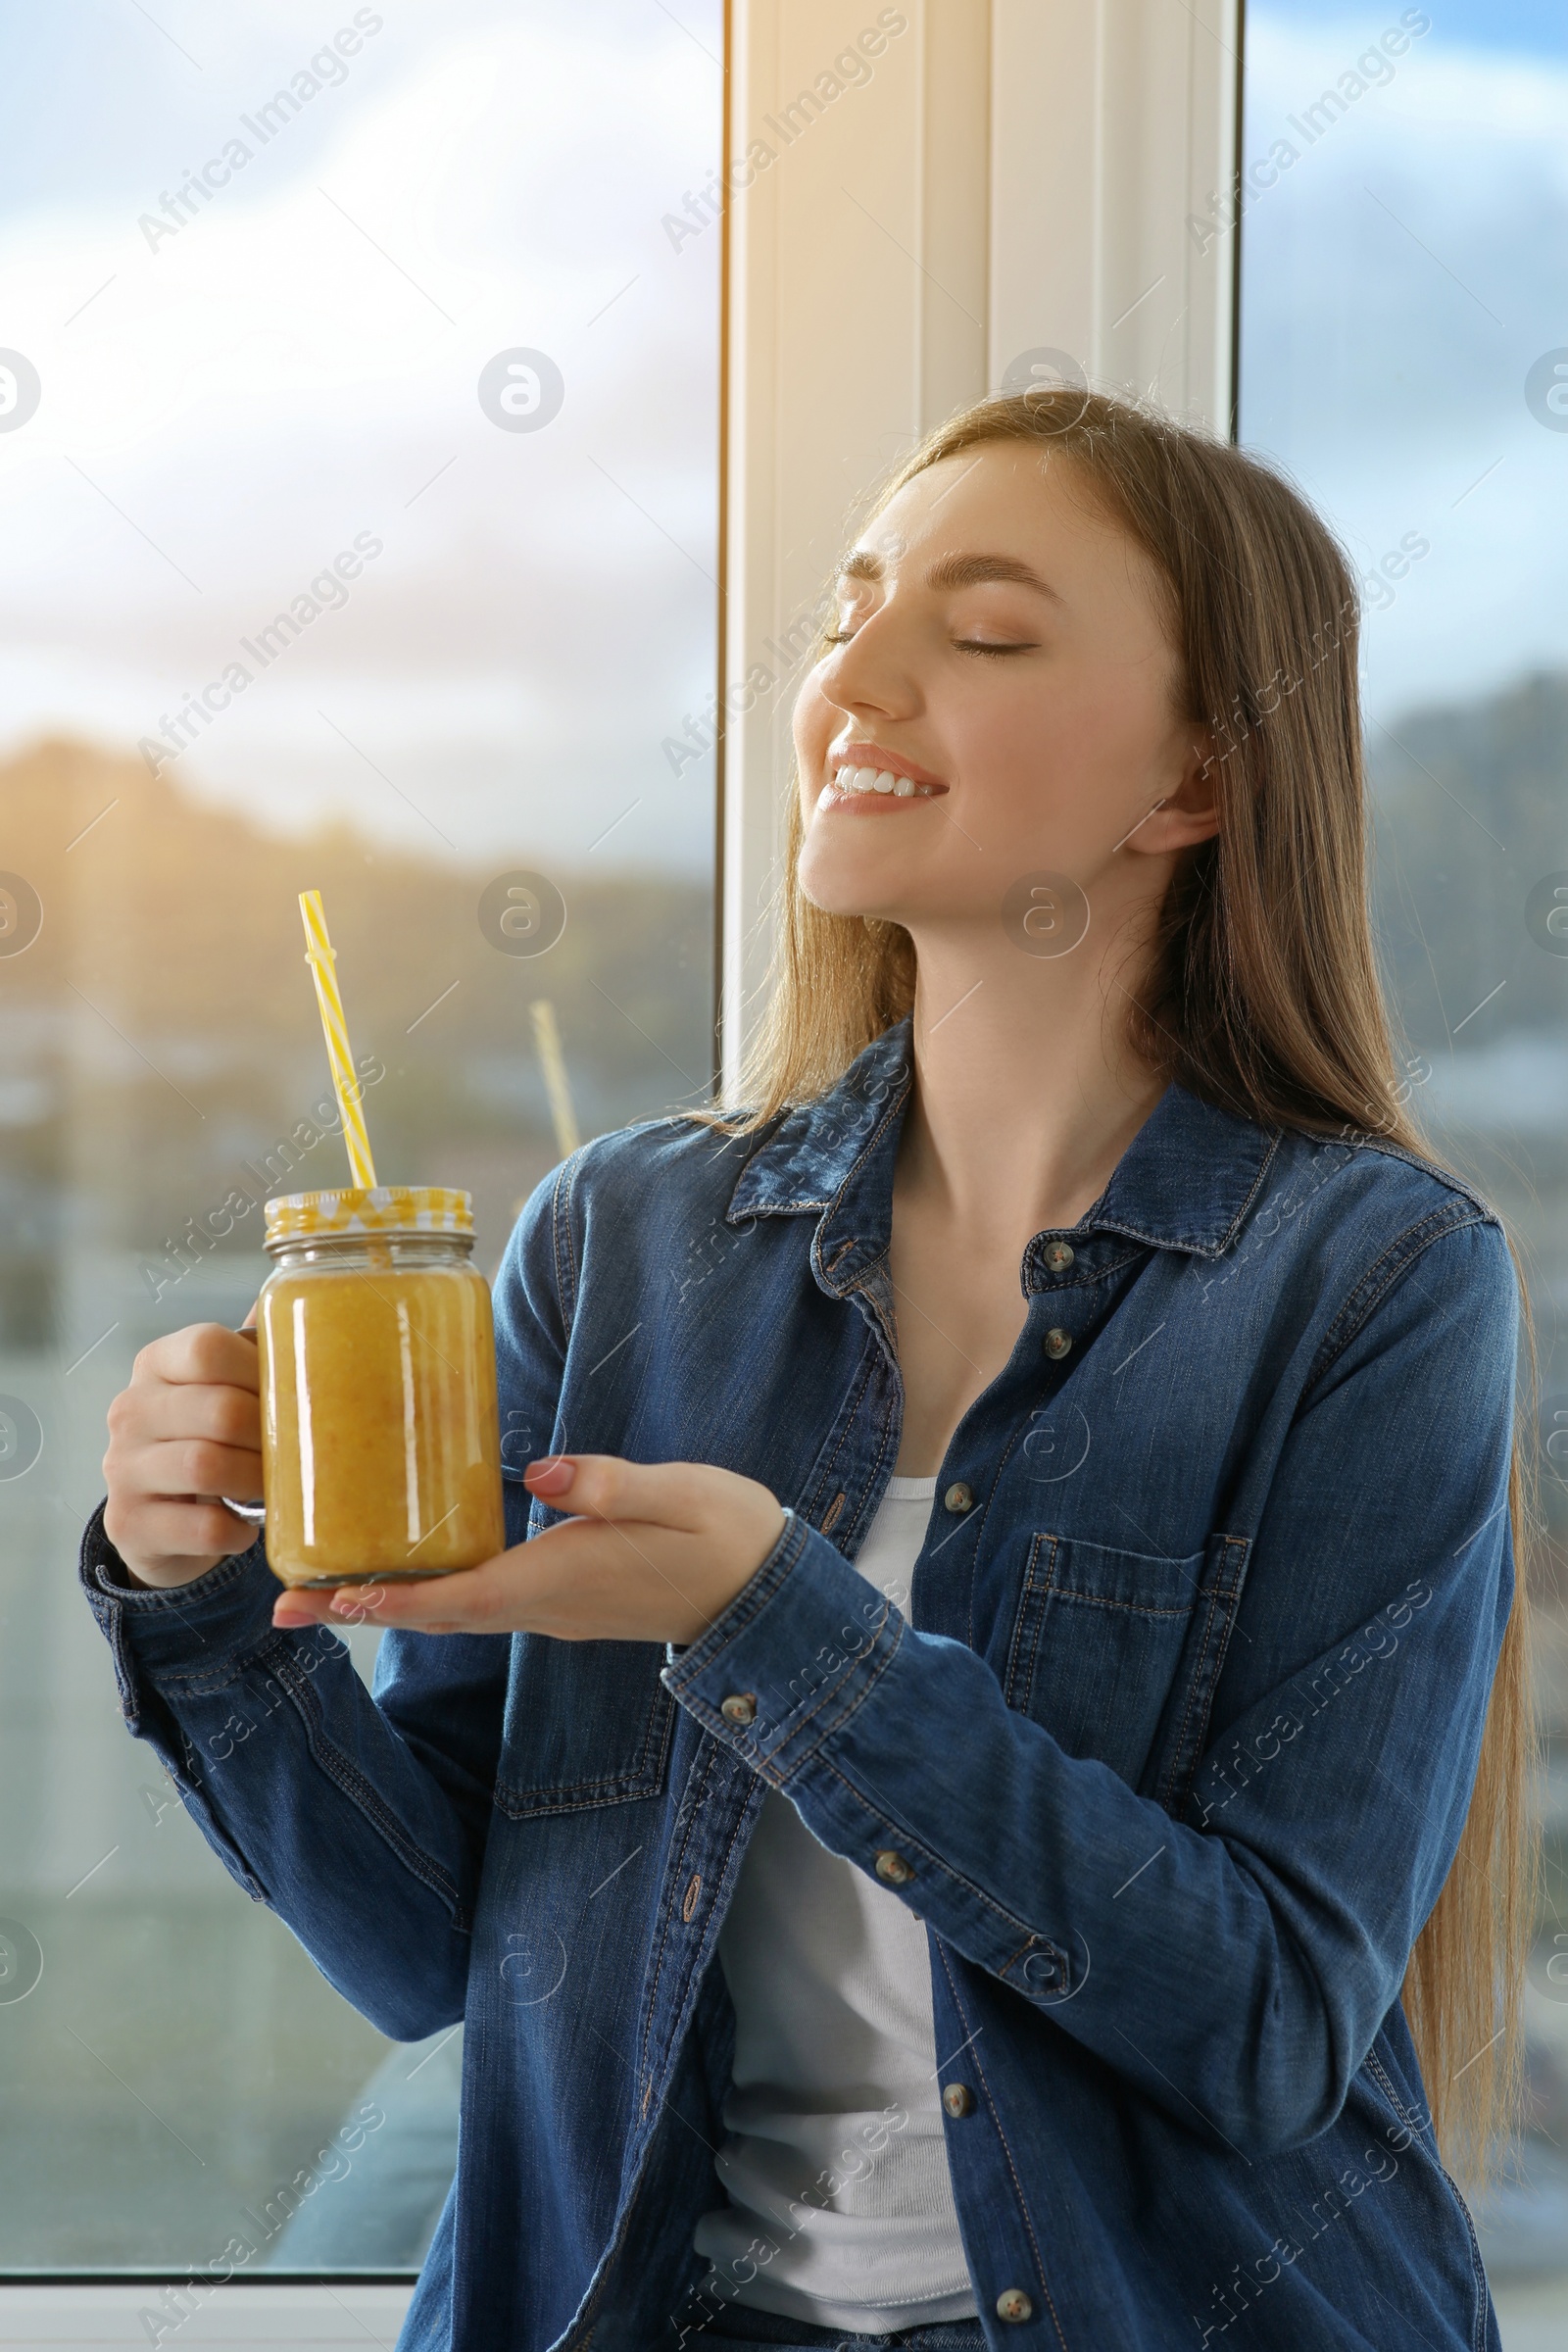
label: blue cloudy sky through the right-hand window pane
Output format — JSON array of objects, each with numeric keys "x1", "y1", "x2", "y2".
[{"x1": 1242, "y1": 0, "x2": 1568, "y2": 717}]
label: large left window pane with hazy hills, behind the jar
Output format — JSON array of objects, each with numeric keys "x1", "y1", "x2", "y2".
[{"x1": 0, "y1": 0, "x2": 721, "y2": 2275}]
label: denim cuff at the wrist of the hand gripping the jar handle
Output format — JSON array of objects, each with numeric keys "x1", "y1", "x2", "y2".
[{"x1": 80, "y1": 1503, "x2": 282, "y2": 1731}]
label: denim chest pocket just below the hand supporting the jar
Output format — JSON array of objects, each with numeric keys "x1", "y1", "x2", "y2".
[{"x1": 496, "y1": 1635, "x2": 674, "y2": 1821}]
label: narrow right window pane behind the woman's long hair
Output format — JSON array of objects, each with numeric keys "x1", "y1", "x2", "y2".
[{"x1": 1242, "y1": 0, "x2": 1568, "y2": 2314}]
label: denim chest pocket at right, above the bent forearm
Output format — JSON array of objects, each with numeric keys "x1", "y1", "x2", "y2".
[{"x1": 1004, "y1": 1536, "x2": 1246, "y2": 1813}]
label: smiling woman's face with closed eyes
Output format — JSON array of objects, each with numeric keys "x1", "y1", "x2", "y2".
[{"x1": 795, "y1": 442, "x2": 1215, "y2": 929}]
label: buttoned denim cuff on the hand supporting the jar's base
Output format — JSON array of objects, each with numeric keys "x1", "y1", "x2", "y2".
[{"x1": 661, "y1": 1510, "x2": 906, "y2": 1788}]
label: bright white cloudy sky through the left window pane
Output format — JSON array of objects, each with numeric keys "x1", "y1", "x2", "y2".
[{"x1": 0, "y1": 0, "x2": 719, "y2": 868}]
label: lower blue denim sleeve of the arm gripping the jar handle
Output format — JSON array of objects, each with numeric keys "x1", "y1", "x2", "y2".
[{"x1": 82, "y1": 1510, "x2": 506, "y2": 2041}]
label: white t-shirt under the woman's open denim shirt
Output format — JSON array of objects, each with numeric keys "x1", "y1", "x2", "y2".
[{"x1": 694, "y1": 1477, "x2": 978, "y2": 2333}]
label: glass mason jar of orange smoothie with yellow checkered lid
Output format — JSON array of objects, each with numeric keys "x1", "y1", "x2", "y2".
[{"x1": 256, "y1": 1186, "x2": 506, "y2": 1586}]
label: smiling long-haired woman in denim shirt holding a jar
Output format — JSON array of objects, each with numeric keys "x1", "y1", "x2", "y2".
[{"x1": 84, "y1": 393, "x2": 1526, "y2": 2352}]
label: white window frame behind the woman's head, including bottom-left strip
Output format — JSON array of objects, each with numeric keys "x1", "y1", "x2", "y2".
[{"x1": 0, "y1": 0, "x2": 1242, "y2": 2352}]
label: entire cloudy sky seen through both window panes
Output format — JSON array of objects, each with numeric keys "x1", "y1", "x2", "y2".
[{"x1": 0, "y1": 0, "x2": 1568, "y2": 870}]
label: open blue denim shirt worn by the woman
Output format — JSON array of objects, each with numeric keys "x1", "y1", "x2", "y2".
[{"x1": 84, "y1": 1023, "x2": 1516, "y2": 2352}]
